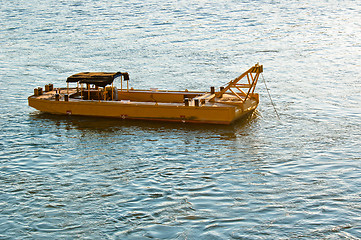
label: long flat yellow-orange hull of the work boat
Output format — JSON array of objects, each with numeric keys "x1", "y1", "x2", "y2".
[{"x1": 28, "y1": 96, "x2": 258, "y2": 124}]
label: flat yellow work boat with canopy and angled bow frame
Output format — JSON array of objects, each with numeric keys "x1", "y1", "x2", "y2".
[{"x1": 28, "y1": 64, "x2": 263, "y2": 124}]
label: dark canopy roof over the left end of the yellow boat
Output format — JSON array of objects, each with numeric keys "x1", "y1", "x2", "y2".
[{"x1": 66, "y1": 72, "x2": 129, "y2": 87}]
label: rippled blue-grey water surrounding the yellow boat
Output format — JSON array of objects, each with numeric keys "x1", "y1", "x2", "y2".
[{"x1": 0, "y1": 0, "x2": 361, "y2": 239}]
